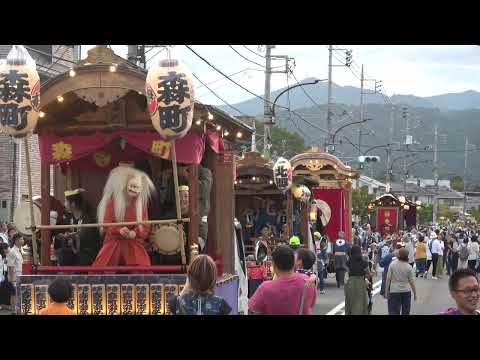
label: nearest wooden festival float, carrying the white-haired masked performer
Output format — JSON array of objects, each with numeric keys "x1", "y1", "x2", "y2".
[{"x1": 9, "y1": 45, "x2": 253, "y2": 315}]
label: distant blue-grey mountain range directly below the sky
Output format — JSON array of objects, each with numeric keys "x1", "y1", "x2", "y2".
[{"x1": 220, "y1": 78, "x2": 480, "y2": 116}]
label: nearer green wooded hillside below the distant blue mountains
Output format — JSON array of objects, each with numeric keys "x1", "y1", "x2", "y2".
[{"x1": 258, "y1": 104, "x2": 480, "y2": 183}]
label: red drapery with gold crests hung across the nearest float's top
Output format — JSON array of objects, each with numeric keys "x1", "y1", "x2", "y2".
[{"x1": 39, "y1": 130, "x2": 223, "y2": 168}]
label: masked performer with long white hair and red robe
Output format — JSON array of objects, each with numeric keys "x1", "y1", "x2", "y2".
[{"x1": 93, "y1": 165, "x2": 154, "y2": 267}]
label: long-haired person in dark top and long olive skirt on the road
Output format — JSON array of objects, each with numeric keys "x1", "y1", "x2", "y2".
[{"x1": 345, "y1": 245, "x2": 369, "y2": 315}]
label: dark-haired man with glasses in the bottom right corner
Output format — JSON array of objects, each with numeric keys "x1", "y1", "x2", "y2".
[{"x1": 443, "y1": 269, "x2": 480, "y2": 315}]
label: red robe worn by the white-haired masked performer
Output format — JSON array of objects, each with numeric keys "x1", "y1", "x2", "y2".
[{"x1": 93, "y1": 200, "x2": 151, "y2": 267}]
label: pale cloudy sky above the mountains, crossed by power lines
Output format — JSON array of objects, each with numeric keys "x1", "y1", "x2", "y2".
[{"x1": 82, "y1": 45, "x2": 480, "y2": 105}]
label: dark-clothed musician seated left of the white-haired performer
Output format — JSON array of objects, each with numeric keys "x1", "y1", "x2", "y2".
[{"x1": 54, "y1": 189, "x2": 100, "y2": 266}]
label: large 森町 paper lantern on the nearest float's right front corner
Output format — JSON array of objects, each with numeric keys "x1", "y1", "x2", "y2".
[{"x1": 145, "y1": 53, "x2": 194, "y2": 140}]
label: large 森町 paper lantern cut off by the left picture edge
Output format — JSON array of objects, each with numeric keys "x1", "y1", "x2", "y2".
[{"x1": 0, "y1": 45, "x2": 40, "y2": 140}]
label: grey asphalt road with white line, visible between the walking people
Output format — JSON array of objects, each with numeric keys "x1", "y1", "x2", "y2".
[{"x1": 313, "y1": 270, "x2": 455, "y2": 315}]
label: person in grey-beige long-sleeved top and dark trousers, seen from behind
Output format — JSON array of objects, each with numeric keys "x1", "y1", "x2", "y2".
[{"x1": 385, "y1": 249, "x2": 417, "y2": 315}]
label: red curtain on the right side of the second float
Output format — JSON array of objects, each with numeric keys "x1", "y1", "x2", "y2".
[{"x1": 312, "y1": 189, "x2": 351, "y2": 241}]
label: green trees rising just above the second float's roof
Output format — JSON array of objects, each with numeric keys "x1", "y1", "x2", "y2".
[{"x1": 255, "y1": 121, "x2": 307, "y2": 159}]
